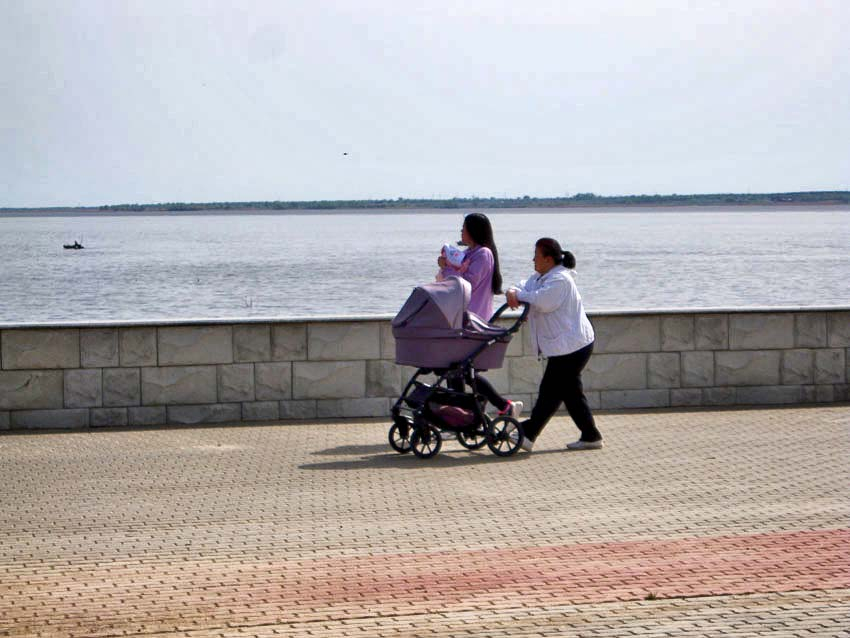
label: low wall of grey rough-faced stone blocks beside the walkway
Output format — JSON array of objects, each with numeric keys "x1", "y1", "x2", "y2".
[{"x1": 0, "y1": 308, "x2": 850, "y2": 429}]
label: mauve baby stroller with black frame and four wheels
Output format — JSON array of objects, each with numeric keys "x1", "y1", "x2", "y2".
[{"x1": 389, "y1": 277, "x2": 528, "y2": 459}]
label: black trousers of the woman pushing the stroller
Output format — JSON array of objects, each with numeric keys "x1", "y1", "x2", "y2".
[{"x1": 522, "y1": 343, "x2": 602, "y2": 441}]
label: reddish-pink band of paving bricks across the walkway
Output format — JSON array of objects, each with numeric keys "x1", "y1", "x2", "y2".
[{"x1": 0, "y1": 529, "x2": 850, "y2": 636}]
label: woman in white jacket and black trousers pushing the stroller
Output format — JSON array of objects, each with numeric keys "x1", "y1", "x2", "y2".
[{"x1": 505, "y1": 237, "x2": 602, "y2": 451}]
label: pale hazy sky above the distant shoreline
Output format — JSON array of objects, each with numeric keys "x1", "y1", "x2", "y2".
[{"x1": 0, "y1": 0, "x2": 850, "y2": 207}]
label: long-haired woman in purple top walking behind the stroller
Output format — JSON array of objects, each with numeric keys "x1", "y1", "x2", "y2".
[{"x1": 437, "y1": 213, "x2": 523, "y2": 418}]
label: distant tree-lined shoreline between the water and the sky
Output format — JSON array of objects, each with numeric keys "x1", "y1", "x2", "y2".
[{"x1": 0, "y1": 191, "x2": 850, "y2": 217}]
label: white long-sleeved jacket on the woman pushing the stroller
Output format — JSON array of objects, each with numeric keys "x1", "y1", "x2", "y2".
[{"x1": 514, "y1": 266, "x2": 595, "y2": 357}]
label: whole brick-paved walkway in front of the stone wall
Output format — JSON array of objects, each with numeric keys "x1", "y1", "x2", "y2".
[{"x1": 0, "y1": 406, "x2": 850, "y2": 637}]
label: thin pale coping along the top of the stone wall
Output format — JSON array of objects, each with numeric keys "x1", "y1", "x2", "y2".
[{"x1": 0, "y1": 305, "x2": 850, "y2": 330}]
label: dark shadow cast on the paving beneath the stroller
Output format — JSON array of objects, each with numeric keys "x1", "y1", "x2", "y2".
[{"x1": 298, "y1": 445, "x2": 531, "y2": 470}]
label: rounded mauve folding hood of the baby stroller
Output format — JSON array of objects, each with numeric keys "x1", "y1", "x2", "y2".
[{"x1": 392, "y1": 277, "x2": 472, "y2": 332}]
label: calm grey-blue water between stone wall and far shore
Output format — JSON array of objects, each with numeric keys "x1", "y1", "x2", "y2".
[{"x1": 0, "y1": 208, "x2": 850, "y2": 322}]
